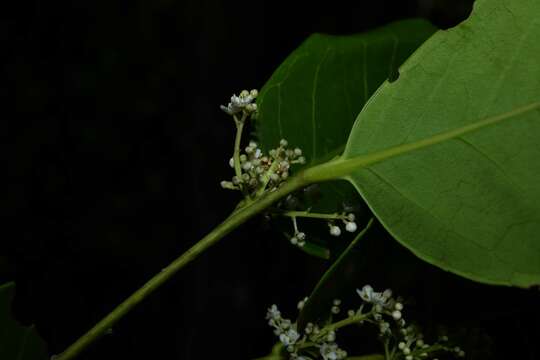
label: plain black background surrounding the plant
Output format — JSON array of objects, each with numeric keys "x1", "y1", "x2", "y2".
[{"x1": 0, "y1": 0, "x2": 540, "y2": 360}]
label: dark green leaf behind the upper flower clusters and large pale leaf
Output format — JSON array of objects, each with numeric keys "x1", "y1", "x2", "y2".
[{"x1": 255, "y1": 19, "x2": 435, "y2": 212}]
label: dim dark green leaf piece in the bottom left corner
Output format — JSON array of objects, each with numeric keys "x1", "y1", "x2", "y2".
[{"x1": 0, "y1": 282, "x2": 49, "y2": 360}]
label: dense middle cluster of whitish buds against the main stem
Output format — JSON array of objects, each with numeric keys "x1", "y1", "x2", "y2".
[{"x1": 221, "y1": 139, "x2": 306, "y2": 195}]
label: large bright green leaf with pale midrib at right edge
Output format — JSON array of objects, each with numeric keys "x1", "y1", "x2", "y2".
[{"x1": 340, "y1": 0, "x2": 540, "y2": 286}]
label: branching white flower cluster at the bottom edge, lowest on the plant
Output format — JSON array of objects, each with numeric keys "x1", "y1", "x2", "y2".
[{"x1": 266, "y1": 285, "x2": 465, "y2": 360}]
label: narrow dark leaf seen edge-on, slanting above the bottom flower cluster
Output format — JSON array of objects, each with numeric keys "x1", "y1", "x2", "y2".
[{"x1": 298, "y1": 219, "x2": 373, "y2": 329}]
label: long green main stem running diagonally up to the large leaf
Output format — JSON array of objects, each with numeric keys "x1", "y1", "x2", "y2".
[{"x1": 55, "y1": 158, "x2": 342, "y2": 360}]
